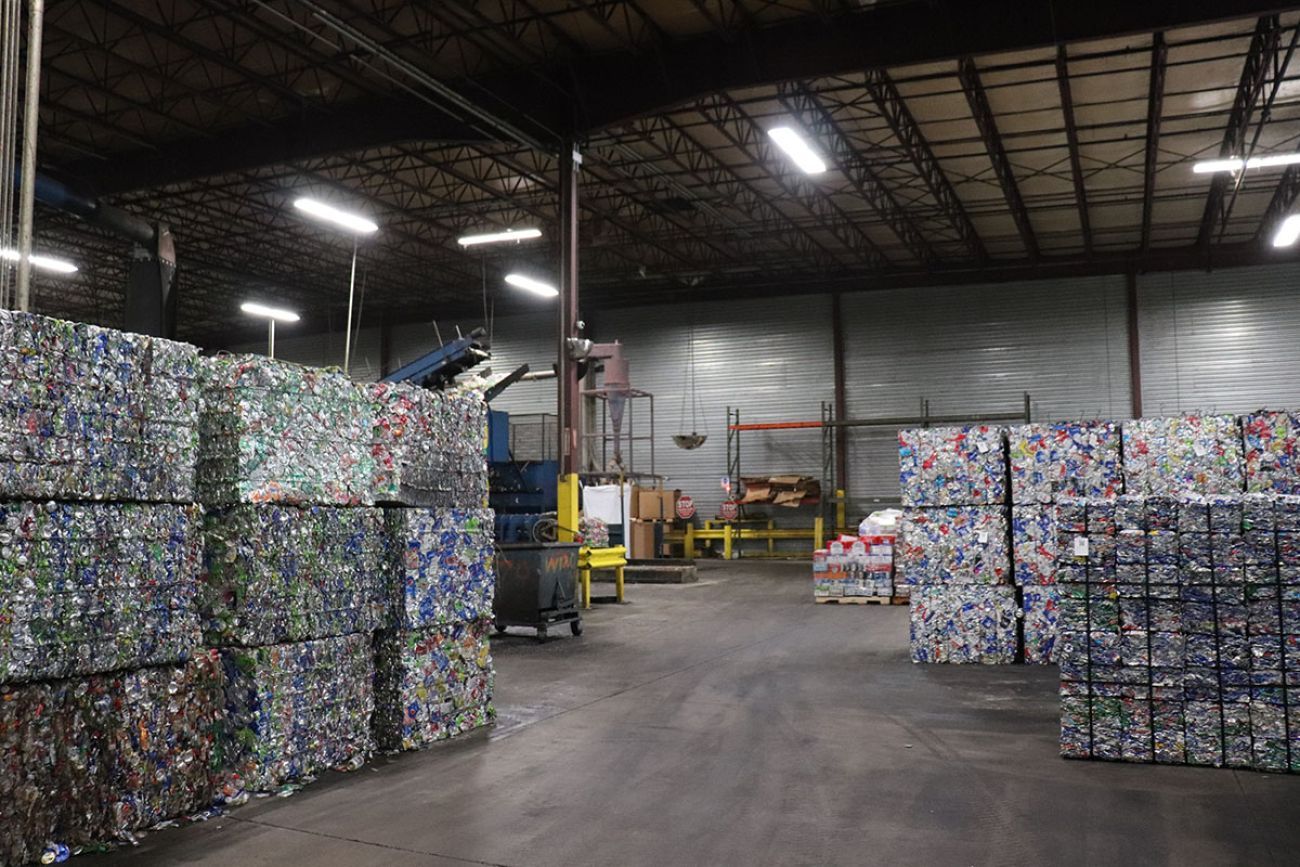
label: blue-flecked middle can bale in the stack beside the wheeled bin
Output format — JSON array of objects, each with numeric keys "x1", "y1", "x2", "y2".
[{"x1": 384, "y1": 508, "x2": 497, "y2": 629}]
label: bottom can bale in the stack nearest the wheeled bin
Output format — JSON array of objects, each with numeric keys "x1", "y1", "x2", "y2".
[{"x1": 374, "y1": 617, "x2": 495, "y2": 750}]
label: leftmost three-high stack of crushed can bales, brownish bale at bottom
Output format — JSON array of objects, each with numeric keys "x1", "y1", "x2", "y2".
[{"x1": 0, "y1": 311, "x2": 221, "y2": 862}]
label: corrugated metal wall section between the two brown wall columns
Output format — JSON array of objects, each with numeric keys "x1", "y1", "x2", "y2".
[{"x1": 842, "y1": 277, "x2": 1130, "y2": 513}]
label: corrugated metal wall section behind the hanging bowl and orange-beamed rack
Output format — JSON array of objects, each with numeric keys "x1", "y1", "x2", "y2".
[{"x1": 594, "y1": 295, "x2": 835, "y2": 526}]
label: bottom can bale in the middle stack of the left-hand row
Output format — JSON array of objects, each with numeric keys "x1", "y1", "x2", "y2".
[{"x1": 216, "y1": 633, "x2": 374, "y2": 797}]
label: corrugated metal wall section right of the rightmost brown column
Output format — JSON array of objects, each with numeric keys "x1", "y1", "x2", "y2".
[{"x1": 1138, "y1": 265, "x2": 1300, "y2": 416}]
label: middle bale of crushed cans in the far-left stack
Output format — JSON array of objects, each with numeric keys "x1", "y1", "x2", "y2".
[{"x1": 0, "y1": 502, "x2": 203, "y2": 684}]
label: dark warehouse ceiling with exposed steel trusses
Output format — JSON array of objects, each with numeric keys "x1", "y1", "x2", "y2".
[{"x1": 22, "y1": 0, "x2": 1300, "y2": 346}]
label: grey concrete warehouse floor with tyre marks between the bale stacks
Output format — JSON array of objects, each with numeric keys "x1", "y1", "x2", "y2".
[{"x1": 104, "y1": 563, "x2": 1300, "y2": 867}]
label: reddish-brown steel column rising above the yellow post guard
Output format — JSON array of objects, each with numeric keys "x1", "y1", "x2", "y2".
[{"x1": 555, "y1": 140, "x2": 582, "y2": 476}]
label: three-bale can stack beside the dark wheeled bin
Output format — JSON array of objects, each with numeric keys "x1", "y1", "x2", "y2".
[{"x1": 374, "y1": 390, "x2": 495, "y2": 750}]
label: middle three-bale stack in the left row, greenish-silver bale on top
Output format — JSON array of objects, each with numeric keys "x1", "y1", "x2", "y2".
[{"x1": 199, "y1": 356, "x2": 385, "y2": 796}]
